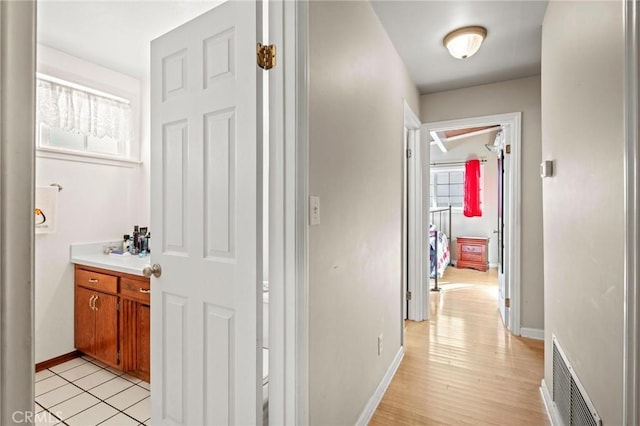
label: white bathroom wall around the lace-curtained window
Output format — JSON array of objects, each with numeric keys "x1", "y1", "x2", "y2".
[{"x1": 35, "y1": 46, "x2": 153, "y2": 363}]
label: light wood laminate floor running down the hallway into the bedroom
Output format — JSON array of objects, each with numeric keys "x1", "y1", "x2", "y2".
[{"x1": 369, "y1": 267, "x2": 549, "y2": 426}]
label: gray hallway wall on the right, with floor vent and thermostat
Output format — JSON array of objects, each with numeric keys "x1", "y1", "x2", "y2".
[{"x1": 542, "y1": 1, "x2": 624, "y2": 425}]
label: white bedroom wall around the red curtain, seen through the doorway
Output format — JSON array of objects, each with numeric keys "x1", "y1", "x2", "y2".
[{"x1": 425, "y1": 133, "x2": 498, "y2": 266}]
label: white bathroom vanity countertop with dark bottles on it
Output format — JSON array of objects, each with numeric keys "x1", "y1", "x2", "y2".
[{"x1": 71, "y1": 241, "x2": 151, "y2": 276}]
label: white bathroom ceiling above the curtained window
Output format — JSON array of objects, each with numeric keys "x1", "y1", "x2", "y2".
[{"x1": 38, "y1": 0, "x2": 220, "y2": 78}]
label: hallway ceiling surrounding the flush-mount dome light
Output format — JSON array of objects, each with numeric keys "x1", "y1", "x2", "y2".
[{"x1": 372, "y1": 0, "x2": 547, "y2": 94}]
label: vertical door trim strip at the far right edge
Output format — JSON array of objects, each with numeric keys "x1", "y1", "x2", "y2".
[{"x1": 622, "y1": 1, "x2": 640, "y2": 425}]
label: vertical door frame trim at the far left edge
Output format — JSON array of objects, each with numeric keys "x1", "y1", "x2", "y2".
[{"x1": 0, "y1": 2, "x2": 36, "y2": 424}]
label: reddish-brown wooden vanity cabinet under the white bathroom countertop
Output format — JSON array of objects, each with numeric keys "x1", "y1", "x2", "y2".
[{"x1": 75, "y1": 264, "x2": 151, "y2": 382}]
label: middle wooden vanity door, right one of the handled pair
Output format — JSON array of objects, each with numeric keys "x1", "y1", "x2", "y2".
[{"x1": 93, "y1": 293, "x2": 119, "y2": 367}]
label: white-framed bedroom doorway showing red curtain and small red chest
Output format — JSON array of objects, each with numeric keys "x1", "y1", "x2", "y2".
[{"x1": 419, "y1": 112, "x2": 521, "y2": 335}]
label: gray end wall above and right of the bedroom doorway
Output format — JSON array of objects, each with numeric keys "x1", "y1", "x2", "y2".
[{"x1": 420, "y1": 76, "x2": 544, "y2": 329}]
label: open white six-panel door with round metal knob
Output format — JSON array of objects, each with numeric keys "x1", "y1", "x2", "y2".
[{"x1": 150, "y1": 1, "x2": 262, "y2": 425}]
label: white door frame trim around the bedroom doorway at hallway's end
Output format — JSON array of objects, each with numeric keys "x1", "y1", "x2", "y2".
[{"x1": 417, "y1": 112, "x2": 522, "y2": 335}]
